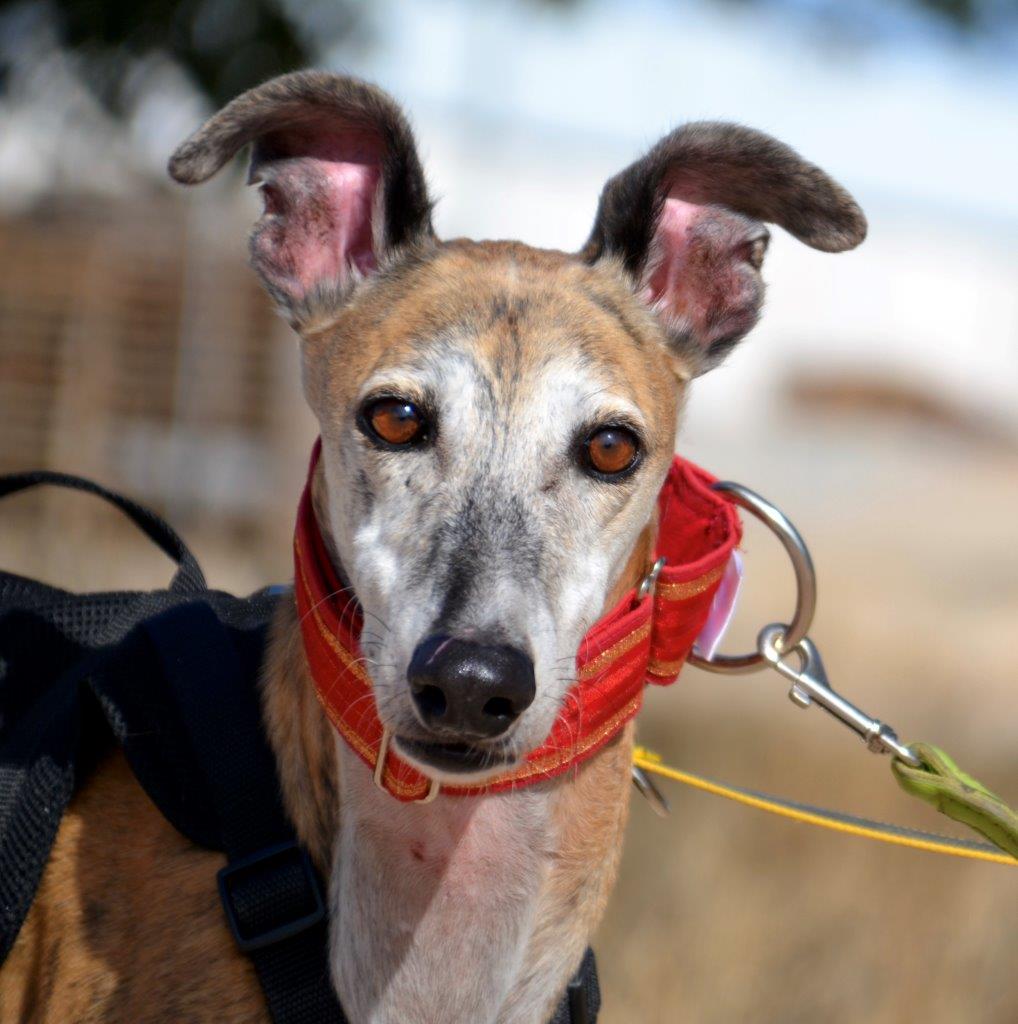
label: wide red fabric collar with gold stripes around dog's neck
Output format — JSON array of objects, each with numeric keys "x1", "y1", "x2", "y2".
[{"x1": 294, "y1": 441, "x2": 741, "y2": 801}]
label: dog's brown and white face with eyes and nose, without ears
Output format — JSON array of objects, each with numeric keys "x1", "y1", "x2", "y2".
[{"x1": 307, "y1": 243, "x2": 676, "y2": 771}]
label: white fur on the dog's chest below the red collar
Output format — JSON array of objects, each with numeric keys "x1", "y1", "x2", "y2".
[{"x1": 330, "y1": 742, "x2": 558, "y2": 1024}]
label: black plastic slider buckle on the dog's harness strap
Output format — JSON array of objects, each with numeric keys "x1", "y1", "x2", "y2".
[{"x1": 217, "y1": 841, "x2": 326, "y2": 953}]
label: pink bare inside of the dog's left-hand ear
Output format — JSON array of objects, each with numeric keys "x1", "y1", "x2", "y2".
[{"x1": 252, "y1": 132, "x2": 381, "y2": 300}]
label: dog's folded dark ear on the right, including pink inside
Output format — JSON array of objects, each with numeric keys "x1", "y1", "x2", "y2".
[{"x1": 581, "y1": 122, "x2": 866, "y2": 374}]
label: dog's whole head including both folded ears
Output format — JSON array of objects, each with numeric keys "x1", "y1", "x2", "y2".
[{"x1": 171, "y1": 73, "x2": 865, "y2": 782}]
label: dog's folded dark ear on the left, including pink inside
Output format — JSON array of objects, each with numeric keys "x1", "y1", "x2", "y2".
[{"x1": 169, "y1": 72, "x2": 434, "y2": 326}]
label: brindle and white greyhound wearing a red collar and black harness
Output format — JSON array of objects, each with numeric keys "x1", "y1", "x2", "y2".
[{"x1": 0, "y1": 72, "x2": 865, "y2": 1024}]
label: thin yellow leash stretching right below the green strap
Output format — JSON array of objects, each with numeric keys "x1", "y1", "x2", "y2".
[{"x1": 633, "y1": 746, "x2": 1018, "y2": 867}]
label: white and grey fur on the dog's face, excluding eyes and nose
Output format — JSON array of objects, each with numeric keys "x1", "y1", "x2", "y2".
[{"x1": 323, "y1": 339, "x2": 667, "y2": 774}]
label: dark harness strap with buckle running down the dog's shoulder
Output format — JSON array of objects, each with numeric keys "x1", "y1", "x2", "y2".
[{"x1": 142, "y1": 602, "x2": 346, "y2": 1024}]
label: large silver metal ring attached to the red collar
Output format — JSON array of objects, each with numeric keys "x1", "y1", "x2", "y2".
[{"x1": 688, "y1": 480, "x2": 816, "y2": 674}]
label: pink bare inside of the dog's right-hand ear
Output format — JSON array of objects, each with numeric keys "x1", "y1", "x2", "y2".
[{"x1": 641, "y1": 194, "x2": 766, "y2": 348}]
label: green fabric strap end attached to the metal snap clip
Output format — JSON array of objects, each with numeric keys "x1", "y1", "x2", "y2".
[{"x1": 891, "y1": 743, "x2": 1018, "y2": 860}]
